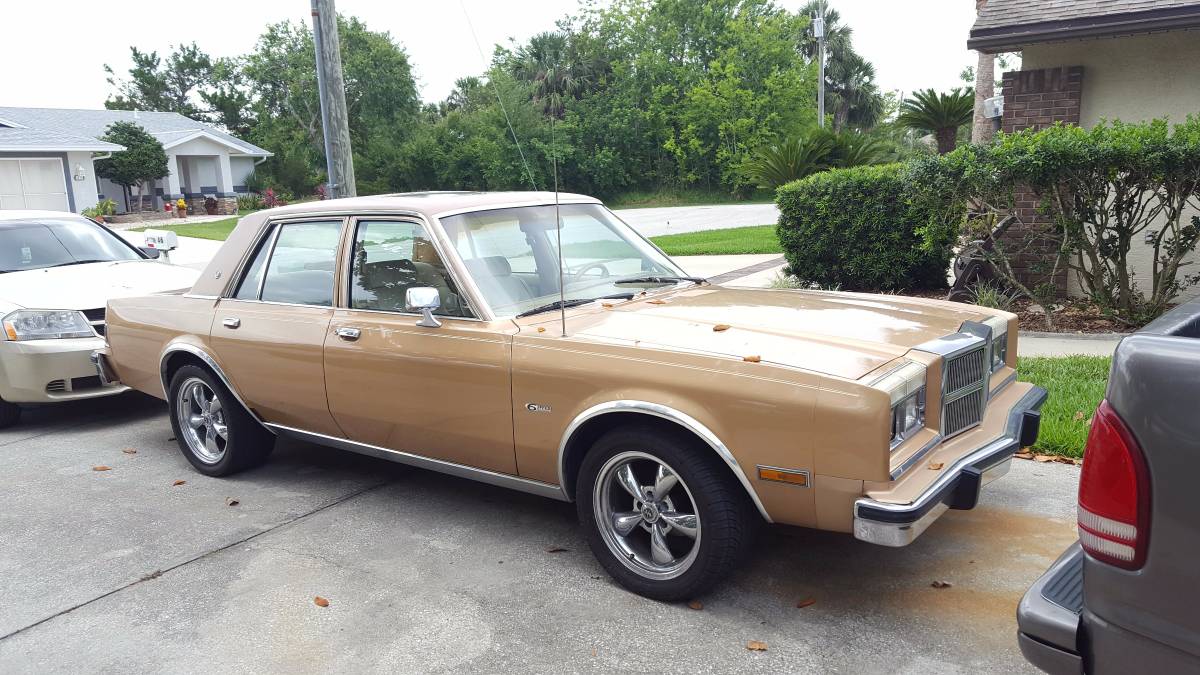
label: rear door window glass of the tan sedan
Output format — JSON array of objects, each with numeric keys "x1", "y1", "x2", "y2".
[{"x1": 234, "y1": 221, "x2": 342, "y2": 306}]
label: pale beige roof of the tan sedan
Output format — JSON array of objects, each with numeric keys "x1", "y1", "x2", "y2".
[{"x1": 260, "y1": 191, "x2": 600, "y2": 217}]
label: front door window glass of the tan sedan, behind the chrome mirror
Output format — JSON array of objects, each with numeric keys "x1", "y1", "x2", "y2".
[{"x1": 350, "y1": 221, "x2": 472, "y2": 317}]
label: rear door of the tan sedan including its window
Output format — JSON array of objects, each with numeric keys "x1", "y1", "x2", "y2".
[{"x1": 210, "y1": 217, "x2": 344, "y2": 437}]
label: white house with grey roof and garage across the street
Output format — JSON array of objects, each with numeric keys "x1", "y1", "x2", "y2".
[{"x1": 0, "y1": 107, "x2": 271, "y2": 214}]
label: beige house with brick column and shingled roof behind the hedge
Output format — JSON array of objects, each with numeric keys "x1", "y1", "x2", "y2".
[{"x1": 967, "y1": 0, "x2": 1200, "y2": 298}]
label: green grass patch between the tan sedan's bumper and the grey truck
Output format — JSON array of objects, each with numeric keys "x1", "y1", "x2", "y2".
[{"x1": 1016, "y1": 357, "x2": 1112, "y2": 458}]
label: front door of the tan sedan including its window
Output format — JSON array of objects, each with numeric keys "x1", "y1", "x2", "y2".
[{"x1": 325, "y1": 217, "x2": 516, "y2": 473}]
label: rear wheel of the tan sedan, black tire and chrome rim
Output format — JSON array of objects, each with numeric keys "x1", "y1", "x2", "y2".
[{"x1": 167, "y1": 365, "x2": 275, "y2": 476}]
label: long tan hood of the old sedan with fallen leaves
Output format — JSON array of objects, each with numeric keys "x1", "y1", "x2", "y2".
[{"x1": 564, "y1": 286, "x2": 989, "y2": 380}]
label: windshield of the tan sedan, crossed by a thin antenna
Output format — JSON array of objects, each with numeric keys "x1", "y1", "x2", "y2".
[{"x1": 442, "y1": 204, "x2": 684, "y2": 316}]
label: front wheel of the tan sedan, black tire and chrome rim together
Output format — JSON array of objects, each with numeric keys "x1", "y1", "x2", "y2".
[{"x1": 576, "y1": 426, "x2": 760, "y2": 601}]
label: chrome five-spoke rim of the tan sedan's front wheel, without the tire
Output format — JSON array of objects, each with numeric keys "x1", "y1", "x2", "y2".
[{"x1": 592, "y1": 452, "x2": 701, "y2": 580}]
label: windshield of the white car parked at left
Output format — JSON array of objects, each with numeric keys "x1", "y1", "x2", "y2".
[{"x1": 0, "y1": 217, "x2": 142, "y2": 274}]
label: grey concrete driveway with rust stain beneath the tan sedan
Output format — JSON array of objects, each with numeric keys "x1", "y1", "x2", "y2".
[{"x1": 0, "y1": 394, "x2": 1079, "y2": 674}]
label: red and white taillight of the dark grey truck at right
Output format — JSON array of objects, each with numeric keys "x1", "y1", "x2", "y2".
[{"x1": 1079, "y1": 401, "x2": 1150, "y2": 569}]
